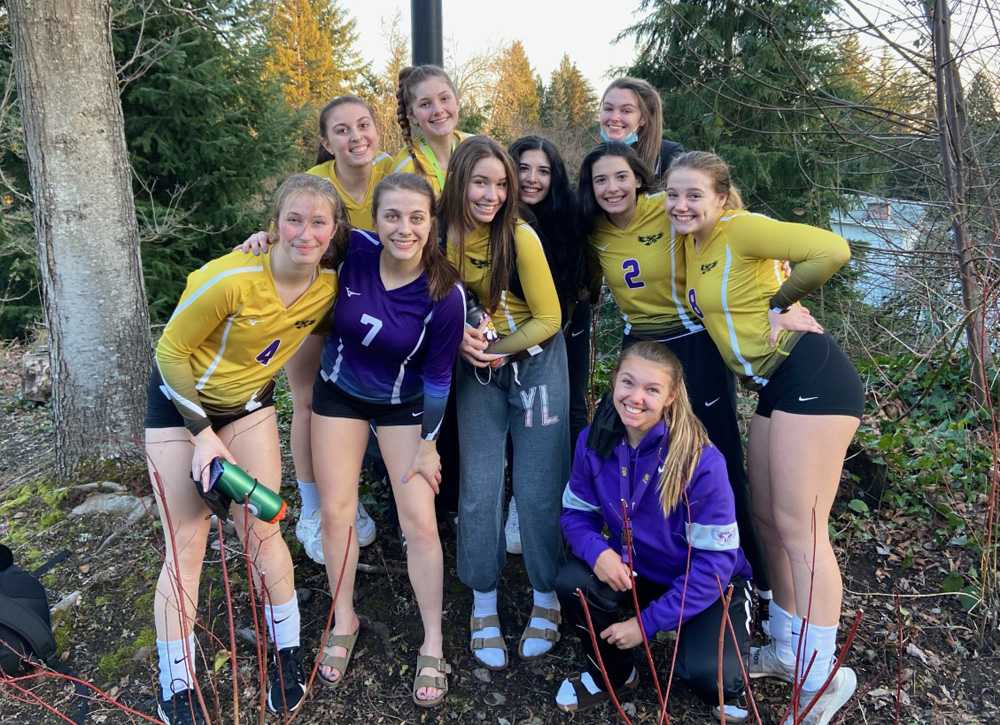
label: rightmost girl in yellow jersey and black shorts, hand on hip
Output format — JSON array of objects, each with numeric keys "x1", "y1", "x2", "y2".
[{"x1": 666, "y1": 152, "x2": 864, "y2": 725}]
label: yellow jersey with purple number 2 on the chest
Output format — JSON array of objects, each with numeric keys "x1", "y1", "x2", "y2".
[{"x1": 590, "y1": 192, "x2": 704, "y2": 337}]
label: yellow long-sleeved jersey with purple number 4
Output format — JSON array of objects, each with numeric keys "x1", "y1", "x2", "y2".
[{"x1": 156, "y1": 252, "x2": 337, "y2": 434}]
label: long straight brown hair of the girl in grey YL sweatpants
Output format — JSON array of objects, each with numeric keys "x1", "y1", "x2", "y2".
[{"x1": 439, "y1": 136, "x2": 518, "y2": 310}]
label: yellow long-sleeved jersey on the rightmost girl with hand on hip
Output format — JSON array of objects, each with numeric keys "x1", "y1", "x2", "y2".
[{"x1": 683, "y1": 210, "x2": 851, "y2": 388}]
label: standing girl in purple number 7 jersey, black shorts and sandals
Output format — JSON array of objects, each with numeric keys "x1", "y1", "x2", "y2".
[{"x1": 312, "y1": 174, "x2": 465, "y2": 707}]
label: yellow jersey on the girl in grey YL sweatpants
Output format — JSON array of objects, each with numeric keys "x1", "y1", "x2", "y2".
[{"x1": 448, "y1": 220, "x2": 562, "y2": 354}]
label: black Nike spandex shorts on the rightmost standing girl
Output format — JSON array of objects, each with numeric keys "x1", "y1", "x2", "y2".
[{"x1": 755, "y1": 332, "x2": 865, "y2": 419}]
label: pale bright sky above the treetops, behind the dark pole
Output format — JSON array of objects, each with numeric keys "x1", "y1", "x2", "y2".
[{"x1": 341, "y1": 0, "x2": 639, "y2": 93}]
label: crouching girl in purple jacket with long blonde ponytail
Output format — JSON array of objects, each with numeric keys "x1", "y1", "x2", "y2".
[{"x1": 556, "y1": 341, "x2": 750, "y2": 722}]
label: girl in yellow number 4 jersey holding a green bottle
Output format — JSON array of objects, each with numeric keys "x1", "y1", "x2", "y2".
[{"x1": 146, "y1": 174, "x2": 348, "y2": 723}]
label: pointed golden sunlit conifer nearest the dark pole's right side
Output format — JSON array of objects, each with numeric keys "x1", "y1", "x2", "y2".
[{"x1": 488, "y1": 40, "x2": 539, "y2": 143}]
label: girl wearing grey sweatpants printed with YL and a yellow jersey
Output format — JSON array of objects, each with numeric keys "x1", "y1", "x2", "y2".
[{"x1": 440, "y1": 136, "x2": 569, "y2": 670}]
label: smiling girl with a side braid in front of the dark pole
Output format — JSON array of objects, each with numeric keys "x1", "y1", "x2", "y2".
[{"x1": 392, "y1": 65, "x2": 470, "y2": 197}]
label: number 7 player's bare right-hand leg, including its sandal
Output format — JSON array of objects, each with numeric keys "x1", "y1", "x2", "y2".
[{"x1": 378, "y1": 425, "x2": 444, "y2": 700}]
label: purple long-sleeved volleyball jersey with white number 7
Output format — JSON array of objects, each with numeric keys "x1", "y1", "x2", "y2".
[{"x1": 320, "y1": 230, "x2": 465, "y2": 440}]
